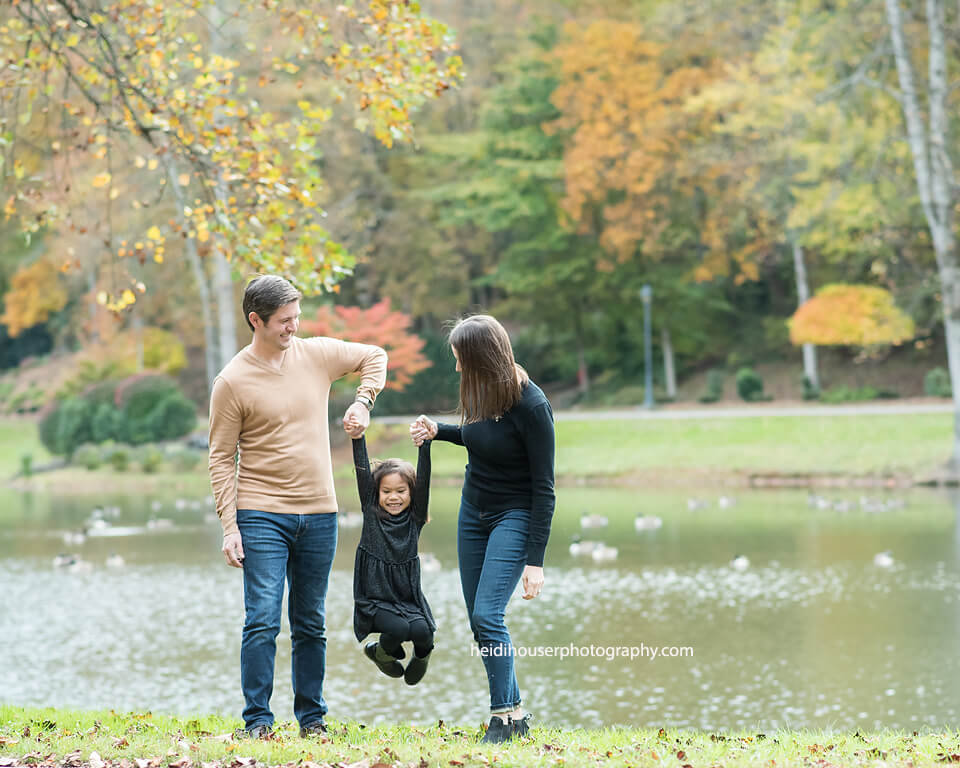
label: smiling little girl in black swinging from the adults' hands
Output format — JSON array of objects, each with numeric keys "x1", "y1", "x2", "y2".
[{"x1": 353, "y1": 428, "x2": 437, "y2": 685}]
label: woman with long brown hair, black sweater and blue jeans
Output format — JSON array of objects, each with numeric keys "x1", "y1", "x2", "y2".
[{"x1": 410, "y1": 315, "x2": 555, "y2": 743}]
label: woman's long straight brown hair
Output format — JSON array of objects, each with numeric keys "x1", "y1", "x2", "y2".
[{"x1": 448, "y1": 315, "x2": 529, "y2": 424}]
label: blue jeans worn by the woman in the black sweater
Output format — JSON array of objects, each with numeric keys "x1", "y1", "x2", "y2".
[{"x1": 457, "y1": 498, "x2": 530, "y2": 713}]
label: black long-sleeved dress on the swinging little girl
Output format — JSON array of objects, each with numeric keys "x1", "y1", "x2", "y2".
[{"x1": 353, "y1": 437, "x2": 437, "y2": 642}]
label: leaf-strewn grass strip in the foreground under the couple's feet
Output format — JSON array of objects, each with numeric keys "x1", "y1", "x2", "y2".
[{"x1": 0, "y1": 706, "x2": 960, "y2": 768}]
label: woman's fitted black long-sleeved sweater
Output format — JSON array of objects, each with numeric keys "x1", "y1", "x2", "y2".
[{"x1": 436, "y1": 381, "x2": 556, "y2": 566}]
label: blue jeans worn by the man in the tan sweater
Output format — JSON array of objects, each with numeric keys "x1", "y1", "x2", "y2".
[{"x1": 237, "y1": 509, "x2": 337, "y2": 728}]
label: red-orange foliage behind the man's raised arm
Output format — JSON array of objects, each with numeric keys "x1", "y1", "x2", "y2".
[{"x1": 300, "y1": 299, "x2": 430, "y2": 392}]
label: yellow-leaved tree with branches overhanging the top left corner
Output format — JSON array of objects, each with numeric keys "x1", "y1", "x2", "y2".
[{"x1": 0, "y1": 0, "x2": 462, "y2": 390}]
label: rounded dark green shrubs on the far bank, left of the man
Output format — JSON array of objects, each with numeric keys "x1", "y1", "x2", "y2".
[{"x1": 40, "y1": 374, "x2": 197, "y2": 456}]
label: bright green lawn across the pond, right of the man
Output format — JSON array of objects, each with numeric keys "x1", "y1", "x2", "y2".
[{"x1": 371, "y1": 414, "x2": 953, "y2": 476}]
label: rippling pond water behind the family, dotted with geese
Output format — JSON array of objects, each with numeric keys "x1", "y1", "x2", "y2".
[{"x1": 0, "y1": 488, "x2": 960, "y2": 729}]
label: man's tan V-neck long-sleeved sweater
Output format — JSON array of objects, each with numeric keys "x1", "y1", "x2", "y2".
[{"x1": 210, "y1": 338, "x2": 387, "y2": 536}]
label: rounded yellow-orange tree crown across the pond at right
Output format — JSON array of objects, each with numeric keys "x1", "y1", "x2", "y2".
[{"x1": 788, "y1": 284, "x2": 914, "y2": 347}]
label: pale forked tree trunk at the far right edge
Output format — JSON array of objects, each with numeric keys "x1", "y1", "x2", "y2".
[{"x1": 885, "y1": 0, "x2": 960, "y2": 464}]
